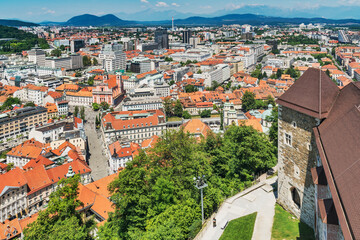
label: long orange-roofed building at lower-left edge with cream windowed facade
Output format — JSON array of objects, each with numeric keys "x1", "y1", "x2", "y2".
[{"x1": 0, "y1": 157, "x2": 91, "y2": 222}]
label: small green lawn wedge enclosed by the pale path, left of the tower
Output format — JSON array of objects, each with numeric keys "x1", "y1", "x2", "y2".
[{"x1": 220, "y1": 212, "x2": 257, "y2": 240}]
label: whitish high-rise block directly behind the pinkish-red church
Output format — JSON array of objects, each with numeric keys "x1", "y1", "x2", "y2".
[{"x1": 99, "y1": 43, "x2": 126, "y2": 72}]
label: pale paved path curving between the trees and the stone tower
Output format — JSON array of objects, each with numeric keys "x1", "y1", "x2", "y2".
[{"x1": 197, "y1": 177, "x2": 277, "y2": 240}]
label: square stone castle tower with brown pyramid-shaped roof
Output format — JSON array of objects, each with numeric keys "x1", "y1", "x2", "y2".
[{"x1": 277, "y1": 68, "x2": 339, "y2": 229}]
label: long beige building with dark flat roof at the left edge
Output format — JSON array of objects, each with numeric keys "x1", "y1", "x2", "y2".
[{"x1": 0, "y1": 106, "x2": 48, "y2": 140}]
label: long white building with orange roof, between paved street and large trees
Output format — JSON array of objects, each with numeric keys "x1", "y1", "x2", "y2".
[{"x1": 101, "y1": 110, "x2": 166, "y2": 144}]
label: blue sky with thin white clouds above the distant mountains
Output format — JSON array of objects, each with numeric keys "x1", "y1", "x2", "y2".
[{"x1": 0, "y1": 0, "x2": 360, "y2": 22}]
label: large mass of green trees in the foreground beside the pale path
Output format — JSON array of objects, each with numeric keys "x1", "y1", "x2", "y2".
[{"x1": 99, "y1": 126, "x2": 276, "y2": 240}]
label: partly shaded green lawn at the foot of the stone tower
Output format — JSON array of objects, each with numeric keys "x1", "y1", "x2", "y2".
[{"x1": 271, "y1": 204, "x2": 315, "y2": 240}]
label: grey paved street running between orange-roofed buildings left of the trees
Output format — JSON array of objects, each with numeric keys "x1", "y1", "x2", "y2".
[{"x1": 85, "y1": 108, "x2": 108, "y2": 181}]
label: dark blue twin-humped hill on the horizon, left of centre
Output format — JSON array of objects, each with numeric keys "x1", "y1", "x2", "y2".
[{"x1": 63, "y1": 14, "x2": 135, "y2": 26}]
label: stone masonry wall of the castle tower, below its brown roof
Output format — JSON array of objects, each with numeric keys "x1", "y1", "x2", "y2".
[{"x1": 278, "y1": 106, "x2": 317, "y2": 229}]
